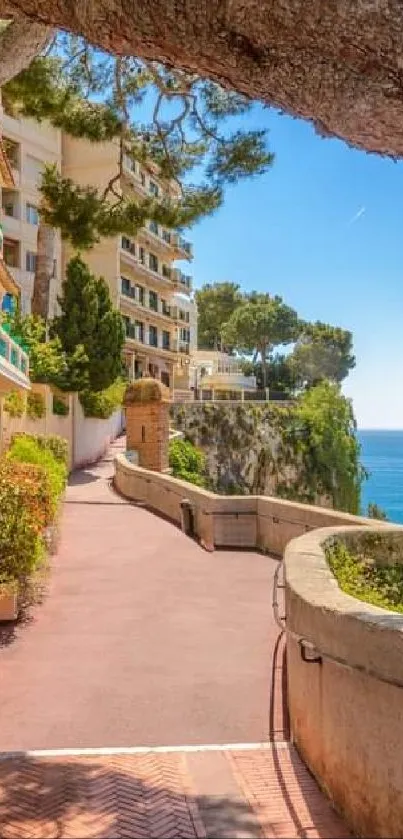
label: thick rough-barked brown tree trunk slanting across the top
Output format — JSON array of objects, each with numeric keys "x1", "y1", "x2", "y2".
[{"x1": 0, "y1": 0, "x2": 403, "y2": 156}]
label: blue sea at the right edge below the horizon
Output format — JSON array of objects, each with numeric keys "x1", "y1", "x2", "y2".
[{"x1": 358, "y1": 430, "x2": 403, "y2": 524}]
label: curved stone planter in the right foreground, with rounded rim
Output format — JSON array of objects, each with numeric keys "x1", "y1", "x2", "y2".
[{"x1": 285, "y1": 527, "x2": 403, "y2": 839}]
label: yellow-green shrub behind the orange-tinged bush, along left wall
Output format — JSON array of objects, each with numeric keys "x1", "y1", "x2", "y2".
[{"x1": 7, "y1": 435, "x2": 67, "y2": 517}]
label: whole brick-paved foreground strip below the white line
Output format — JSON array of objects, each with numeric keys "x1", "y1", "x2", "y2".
[{"x1": 0, "y1": 744, "x2": 350, "y2": 839}]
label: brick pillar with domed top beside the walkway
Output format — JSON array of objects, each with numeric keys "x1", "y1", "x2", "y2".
[{"x1": 124, "y1": 378, "x2": 169, "y2": 472}]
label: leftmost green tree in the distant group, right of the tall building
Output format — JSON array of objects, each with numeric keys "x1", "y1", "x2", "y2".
[{"x1": 195, "y1": 283, "x2": 242, "y2": 350}]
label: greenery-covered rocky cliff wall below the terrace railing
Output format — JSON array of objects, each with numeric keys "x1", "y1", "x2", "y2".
[{"x1": 171, "y1": 384, "x2": 364, "y2": 513}]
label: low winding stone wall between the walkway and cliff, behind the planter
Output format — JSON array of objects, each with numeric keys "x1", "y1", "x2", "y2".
[{"x1": 115, "y1": 455, "x2": 386, "y2": 556}]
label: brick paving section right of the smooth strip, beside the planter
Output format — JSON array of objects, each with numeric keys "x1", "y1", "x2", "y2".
[{"x1": 227, "y1": 743, "x2": 352, "y2": 839}]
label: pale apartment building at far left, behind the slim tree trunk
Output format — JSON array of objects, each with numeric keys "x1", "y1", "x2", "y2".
[{"x1": 0, "y1": 105, "x2": 62, "y2": 316}]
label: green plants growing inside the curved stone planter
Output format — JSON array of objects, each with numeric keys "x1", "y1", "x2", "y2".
[{"x1": 326, "y1": 543, "x2": 403, "y2": 612}]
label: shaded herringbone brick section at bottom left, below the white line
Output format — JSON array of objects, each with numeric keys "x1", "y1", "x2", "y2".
[{"x1": 0, "y1": 753, "x2": 205, "y2": 839}]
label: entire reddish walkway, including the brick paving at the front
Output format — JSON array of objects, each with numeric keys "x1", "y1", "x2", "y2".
[{"x1": 0, "y1": 443, "x2": 354, "y2": 839}]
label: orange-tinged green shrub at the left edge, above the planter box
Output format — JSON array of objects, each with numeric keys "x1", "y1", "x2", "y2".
[{"x1": 0, "y1": 460, "x2": 46, "y2": 585}]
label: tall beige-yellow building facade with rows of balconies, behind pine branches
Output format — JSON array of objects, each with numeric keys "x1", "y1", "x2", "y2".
[{"x1": 62, "y1": 136, "x2": 196, "y2": 391}]
